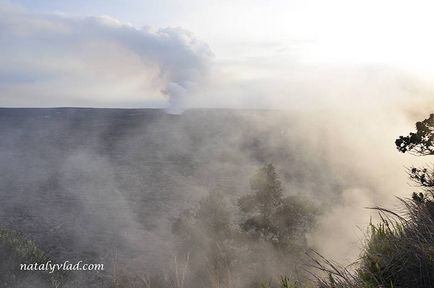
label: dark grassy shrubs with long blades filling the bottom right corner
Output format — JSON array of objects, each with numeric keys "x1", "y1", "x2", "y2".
[{"x1": 317, "y1": 188, "x2": 434, "y2": 288}]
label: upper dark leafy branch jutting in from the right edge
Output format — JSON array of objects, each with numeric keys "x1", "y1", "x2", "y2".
[{"x1": 395, "y1": 114, "x2": 434, "y2": 156}]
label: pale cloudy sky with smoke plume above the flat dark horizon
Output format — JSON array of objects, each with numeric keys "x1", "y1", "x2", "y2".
[{"x1": 0, "y1": 0, "x2": 434, "y2": 109}]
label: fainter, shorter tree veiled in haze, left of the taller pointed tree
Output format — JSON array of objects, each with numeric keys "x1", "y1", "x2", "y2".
[{"x1": 172, "y1": 191, "x2": 235, "y2": 288}]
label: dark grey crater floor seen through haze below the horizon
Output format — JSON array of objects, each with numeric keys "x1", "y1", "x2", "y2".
[{"x1": 0, "y1": 108, "x2": 345, "y2": 285}]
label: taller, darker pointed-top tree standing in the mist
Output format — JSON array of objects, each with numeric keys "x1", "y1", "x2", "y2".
[{"x1": 238, "y1": 164, "x2": 314, "y2": 248}]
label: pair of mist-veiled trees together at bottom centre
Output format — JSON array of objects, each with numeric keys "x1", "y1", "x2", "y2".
[{"x1": 172, "y1": 164, "x2": 316, "y2": 288}]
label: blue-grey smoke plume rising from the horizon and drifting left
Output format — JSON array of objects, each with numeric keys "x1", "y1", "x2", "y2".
[{"x1": 0, "y1": 2, "x2": 212, "y2": 107}]
